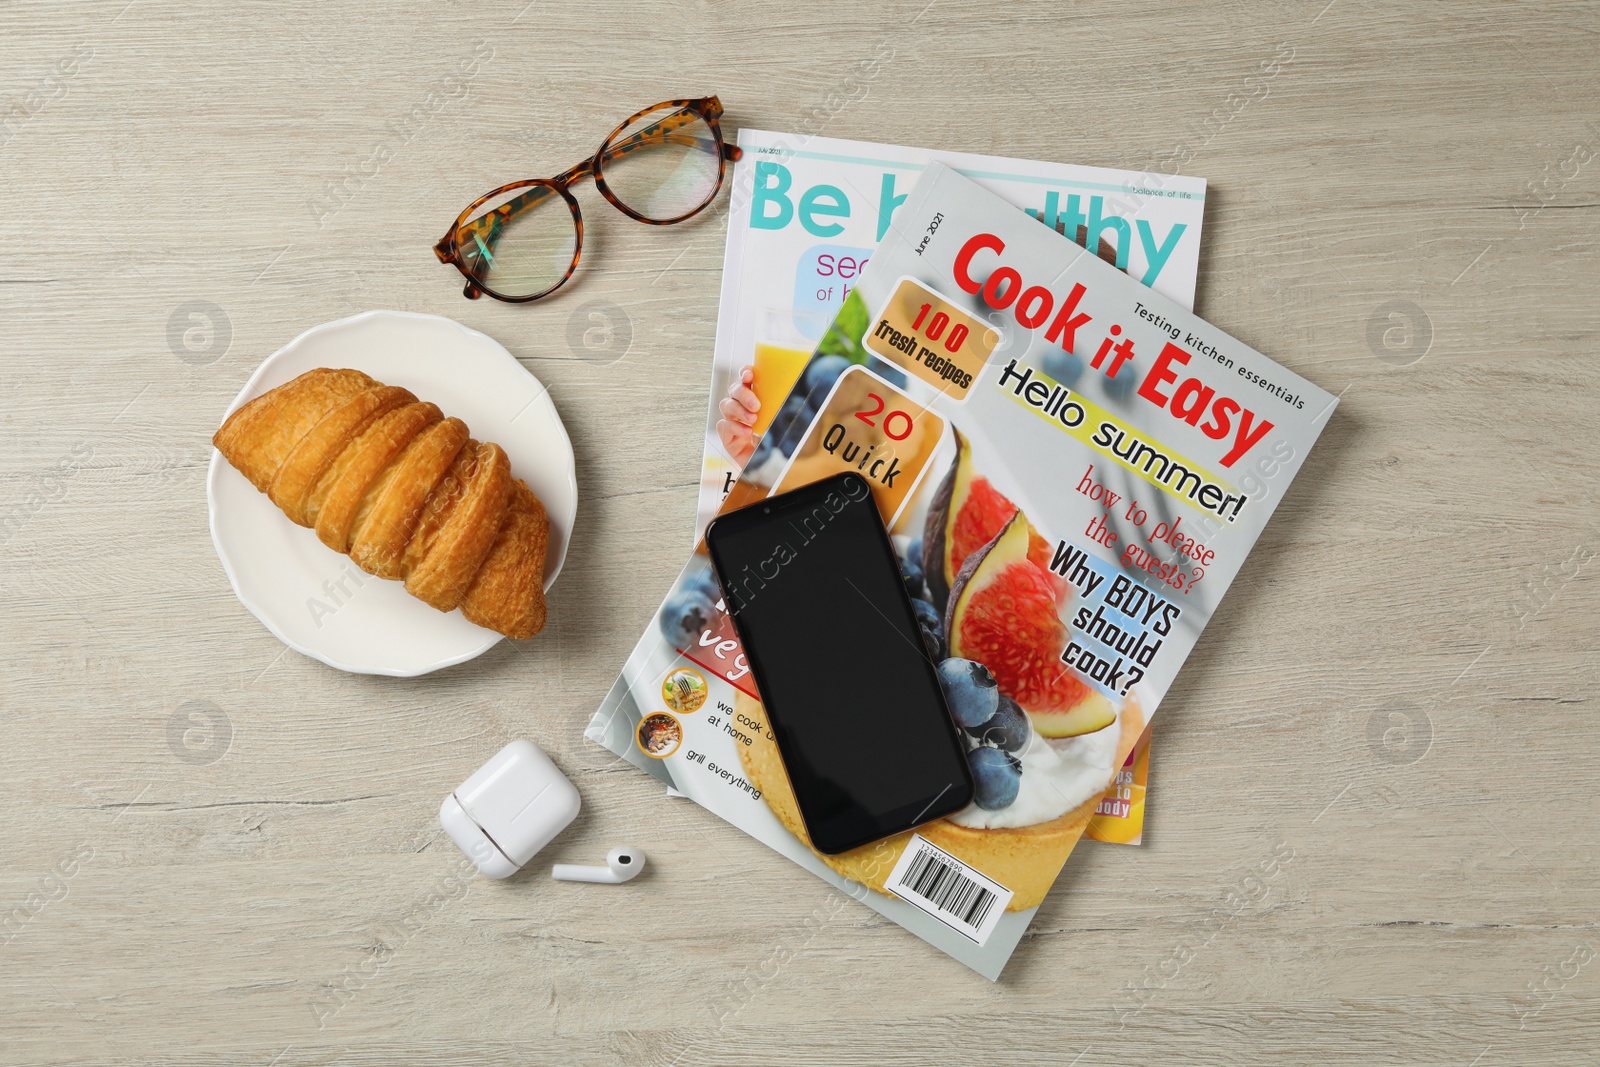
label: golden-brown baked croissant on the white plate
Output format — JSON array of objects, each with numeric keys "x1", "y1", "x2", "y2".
[{"x1": 211, "y1": 368, "x2": 550, "y2": 638}]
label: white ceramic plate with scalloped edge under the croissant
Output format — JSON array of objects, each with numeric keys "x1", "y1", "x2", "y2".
[{"x1": 206, "y1": 312, "x2": 578, "y2": 677}]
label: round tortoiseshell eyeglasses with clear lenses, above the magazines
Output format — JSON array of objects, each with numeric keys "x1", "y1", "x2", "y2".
[{"x1": 434, "y1": 96, "x2": 741, "y2": 304}]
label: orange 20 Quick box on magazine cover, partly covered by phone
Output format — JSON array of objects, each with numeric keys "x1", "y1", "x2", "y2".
[{"x1": 771, "y1": 366, "x2": 944, "y2": 530}]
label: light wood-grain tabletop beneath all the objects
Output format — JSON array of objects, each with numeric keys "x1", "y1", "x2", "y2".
[{"x1": 0, "y1": 0, "x2": 1600, "y2": 1067}]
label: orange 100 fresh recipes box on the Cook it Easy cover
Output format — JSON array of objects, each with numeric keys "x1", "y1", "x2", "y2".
[{"x1": 861, "y1": 278, "x2": 1000, "y2": 400}]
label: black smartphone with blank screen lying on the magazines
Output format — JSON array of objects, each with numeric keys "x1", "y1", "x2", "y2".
[{"x1": 706, "y1": 470, "x2": 973, "y2": 856}]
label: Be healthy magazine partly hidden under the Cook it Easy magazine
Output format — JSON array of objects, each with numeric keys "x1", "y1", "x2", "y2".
[{"x1": 694, "y1": 130, "x2": 1205, "y2": 845}]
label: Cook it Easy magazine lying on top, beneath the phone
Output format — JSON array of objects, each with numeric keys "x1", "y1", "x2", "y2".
[{"x1": 587, "y1": 163, "x2": 1336, "y2": 979}]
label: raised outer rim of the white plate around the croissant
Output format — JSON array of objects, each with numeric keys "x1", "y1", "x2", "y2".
[{"x1": 205, "y1": 309, "x2": 578, "y2": 678}]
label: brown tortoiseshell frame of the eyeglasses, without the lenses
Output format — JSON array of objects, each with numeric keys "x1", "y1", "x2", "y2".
[{"x1": 434, "y1": 96, "x2": 742, "y2": 304}]
